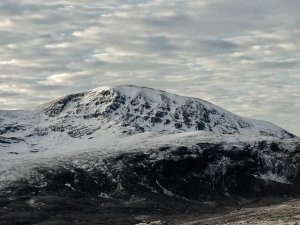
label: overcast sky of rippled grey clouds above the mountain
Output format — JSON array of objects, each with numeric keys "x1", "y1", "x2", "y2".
[{"x1": 0, "y1": 0, "x2": 300, "y2": 135}]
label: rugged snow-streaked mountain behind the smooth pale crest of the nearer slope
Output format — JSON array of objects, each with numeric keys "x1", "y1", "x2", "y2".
[{"x1": 0, "y1": 86, "x2": 294, "y2": 150}]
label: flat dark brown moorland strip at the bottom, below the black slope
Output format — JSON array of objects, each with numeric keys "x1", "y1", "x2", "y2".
[{"x1": 0, "y1": 191, "x2": 300, "y2": 225}]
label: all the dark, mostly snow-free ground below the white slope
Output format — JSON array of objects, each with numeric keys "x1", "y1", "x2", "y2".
[{"x1": 0, "y1": 141, "x2": 300, "y2": 225}]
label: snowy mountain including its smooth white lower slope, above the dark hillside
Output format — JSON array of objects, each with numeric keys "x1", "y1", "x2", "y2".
[{"x1": 0, "y1": 86, "x2": 295, "y2": 186}]
